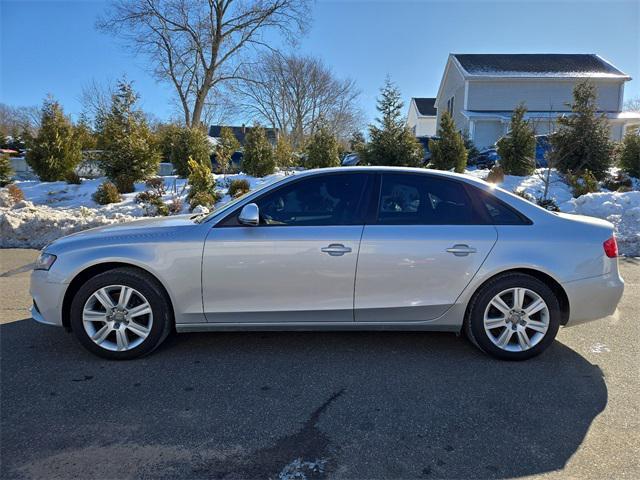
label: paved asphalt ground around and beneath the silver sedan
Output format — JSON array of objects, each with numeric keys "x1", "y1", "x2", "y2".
[{"x1": 0, "y1": 250, "x2": 640, "y2": 479}]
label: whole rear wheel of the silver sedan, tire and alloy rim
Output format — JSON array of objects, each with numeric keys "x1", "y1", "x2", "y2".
[{"x1": 464, "y1": 273, "x2": 561, "y2": 360}]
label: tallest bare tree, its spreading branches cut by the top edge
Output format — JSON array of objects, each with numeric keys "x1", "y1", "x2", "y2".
[{"x1": 98, "y1": 0, "x2": 309, "y2": 126}]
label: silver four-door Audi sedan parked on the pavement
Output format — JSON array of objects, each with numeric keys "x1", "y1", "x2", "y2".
[{"x1": 31, "y1": 167, "x2": 624, "y2": 360}]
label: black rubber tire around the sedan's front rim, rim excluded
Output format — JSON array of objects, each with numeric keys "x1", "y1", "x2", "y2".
[{"x1": 70, "y1": 269, "x2": 173, "y2": 360}]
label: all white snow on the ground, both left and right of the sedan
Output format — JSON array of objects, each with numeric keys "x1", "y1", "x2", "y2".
[{"x1": 0, "y1": 169, "x2": 640, "y2": 256}]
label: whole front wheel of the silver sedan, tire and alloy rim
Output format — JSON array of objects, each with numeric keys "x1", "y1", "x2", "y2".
[{"x1": 70, "y1": 268, "x2": 173, "y2": 360}]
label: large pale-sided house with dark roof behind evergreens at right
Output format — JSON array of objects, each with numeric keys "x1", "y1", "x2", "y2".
[{"x1": 436, "y1": 54, "x2": 640, "y2": 148}]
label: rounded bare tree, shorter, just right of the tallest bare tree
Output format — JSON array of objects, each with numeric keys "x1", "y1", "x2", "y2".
[{"x1": 234, "y1": 52, "x2": 362, "y2": 147}]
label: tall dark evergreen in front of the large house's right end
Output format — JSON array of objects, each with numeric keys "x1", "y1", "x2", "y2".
[{"x1": 550, "y1": 81, "x2": 613, "y2": 180}]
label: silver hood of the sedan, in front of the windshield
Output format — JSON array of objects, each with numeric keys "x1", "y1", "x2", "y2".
[{"x1": 46, "y1": 214, "x2": 197, "y2": 251}]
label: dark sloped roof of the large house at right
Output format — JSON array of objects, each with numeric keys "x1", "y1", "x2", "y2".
[{"x1": 452, "y1": 53, "x2": 629, "y2": 78}]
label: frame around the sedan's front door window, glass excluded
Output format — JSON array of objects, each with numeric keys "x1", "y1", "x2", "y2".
[{"x1": 212, "y1": 171, "x2": 377, "y2": 228}]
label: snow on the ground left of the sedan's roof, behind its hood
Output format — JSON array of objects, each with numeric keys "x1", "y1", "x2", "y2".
[{"x1": 0, "y1": 173, "x2": 284, "y2": 248}]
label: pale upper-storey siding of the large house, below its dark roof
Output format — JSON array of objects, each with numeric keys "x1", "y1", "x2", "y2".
[{"x1": 467, "y1": 79, "x2": 624, "y2": 112}]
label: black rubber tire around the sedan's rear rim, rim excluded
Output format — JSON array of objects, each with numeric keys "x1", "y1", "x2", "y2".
[{"x1": 467, "y1": 273, "x2": 561, "y2": 360}]
